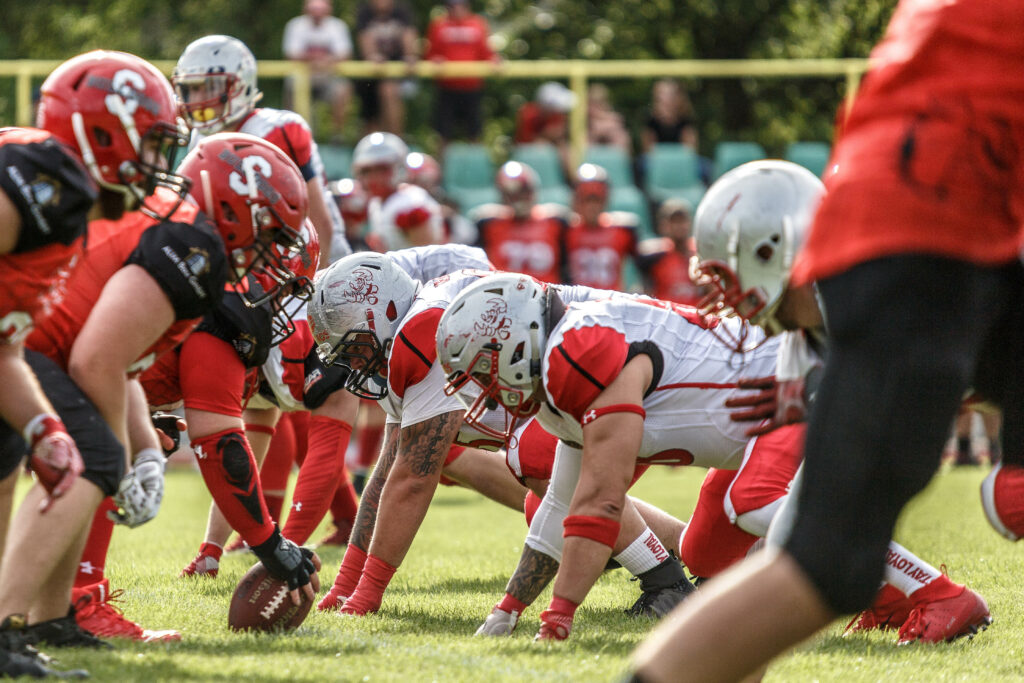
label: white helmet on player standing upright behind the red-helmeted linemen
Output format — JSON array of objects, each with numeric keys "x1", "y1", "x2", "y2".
[{"x1": 171, "y1": 36, "x2": 263, "y2": 135}]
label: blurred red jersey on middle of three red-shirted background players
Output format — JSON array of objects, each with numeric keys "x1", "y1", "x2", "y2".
[{"x1": 565, "y1": 211, "x2": 637, "y2": 290}]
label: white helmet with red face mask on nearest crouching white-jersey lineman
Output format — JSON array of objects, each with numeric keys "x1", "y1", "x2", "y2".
[{"x1": 437, "y1": 272, "x2": 557, "y2": 442}]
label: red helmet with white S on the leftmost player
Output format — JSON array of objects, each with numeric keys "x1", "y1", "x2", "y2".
[{"x1": 37, "y1": 50, "x2": 188, "y2": 220}]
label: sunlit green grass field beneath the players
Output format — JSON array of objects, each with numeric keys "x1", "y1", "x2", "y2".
[{"x1": 28, "y1": 468, "x2": 1024, "y2": 682}]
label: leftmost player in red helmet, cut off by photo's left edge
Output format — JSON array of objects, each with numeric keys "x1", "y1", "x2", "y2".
[{"x1": 0, "y1": 51, "x2": 186, "y2": 676}]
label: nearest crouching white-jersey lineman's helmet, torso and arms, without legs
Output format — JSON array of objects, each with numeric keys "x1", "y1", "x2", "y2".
[{"x1": 437, "y1": 274, "x2": 777, "y2": 640}]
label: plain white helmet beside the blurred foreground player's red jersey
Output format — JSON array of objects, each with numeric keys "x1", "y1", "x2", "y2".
[{"x1": 690, "y1": 160, "x2": 824, "y2": 350}]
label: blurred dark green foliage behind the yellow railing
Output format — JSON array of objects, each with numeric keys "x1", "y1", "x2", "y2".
[{"x1": 0, "y1": 0, "x2": 895, "y2": 156}]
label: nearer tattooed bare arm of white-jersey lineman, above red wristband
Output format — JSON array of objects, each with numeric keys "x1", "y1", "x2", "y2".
[{"x1": 362, "y1": 411, "x2": 465, "y2": 567}]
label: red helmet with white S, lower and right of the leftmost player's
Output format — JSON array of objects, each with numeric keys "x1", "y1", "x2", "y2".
[{"x1": 178, "y1": 133, "x2": 308, "y2": 305}]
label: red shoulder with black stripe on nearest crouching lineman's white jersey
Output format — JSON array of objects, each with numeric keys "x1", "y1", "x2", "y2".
[{"x1": 545, "y1": 326, "x2": 629, "y2": 422}]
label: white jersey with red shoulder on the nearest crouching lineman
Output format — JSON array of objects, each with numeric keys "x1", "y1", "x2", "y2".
[{"x1": 538, "y1": 298, "x2": 778, "y2": 469}]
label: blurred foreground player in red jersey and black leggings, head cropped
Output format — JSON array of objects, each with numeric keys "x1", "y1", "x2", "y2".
[{"x1": 622, "y1": 0, "x2": 1024, "y2": 681}]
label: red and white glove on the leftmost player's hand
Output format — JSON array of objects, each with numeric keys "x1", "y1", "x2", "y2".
[{"x1": 25, "y1": 413, "x2": 85, "y2": 512}]
